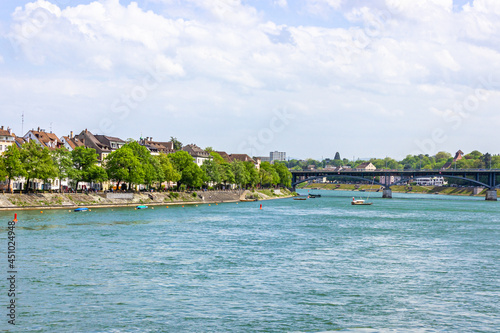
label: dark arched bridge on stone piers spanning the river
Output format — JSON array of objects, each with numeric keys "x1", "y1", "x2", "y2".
[{"x1": 291, "y1": 169, "x2": 500, "y2": 201}]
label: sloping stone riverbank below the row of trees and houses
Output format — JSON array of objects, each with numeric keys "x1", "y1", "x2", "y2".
[{"x1": 0, "y1": 189, "x2": 292, "y2": 211}]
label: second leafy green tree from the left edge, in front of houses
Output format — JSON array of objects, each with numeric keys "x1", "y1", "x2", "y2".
[{"x1": 20, "y1": 140, "x2": 57, "y2": 192}]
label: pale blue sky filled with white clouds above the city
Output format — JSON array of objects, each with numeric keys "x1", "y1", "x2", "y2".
[{"x1": 0, "y1": 0, "x2": 500, "y2": 159}]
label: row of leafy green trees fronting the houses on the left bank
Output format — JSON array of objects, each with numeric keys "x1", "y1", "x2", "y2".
[{"x1": 0, "y1": 141, "x2": 292, "y2": 192}]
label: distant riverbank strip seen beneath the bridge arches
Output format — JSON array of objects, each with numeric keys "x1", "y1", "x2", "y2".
[{"x1": 301, "y1": 183, "x2": 500, "y2": 197}]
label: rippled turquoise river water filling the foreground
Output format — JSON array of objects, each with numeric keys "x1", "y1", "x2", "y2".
[{"x1": 0, "y1": 191, "x2": 500, "y2": 333}]
